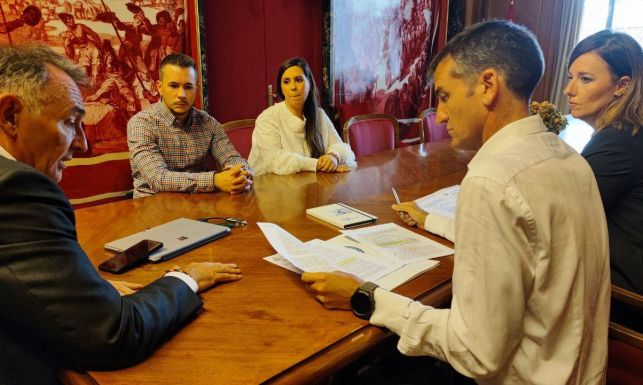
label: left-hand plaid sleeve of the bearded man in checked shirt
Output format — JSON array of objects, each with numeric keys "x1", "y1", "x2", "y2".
[{"x1": 127, "y1": 116, "x2": 216, "y2": 192}]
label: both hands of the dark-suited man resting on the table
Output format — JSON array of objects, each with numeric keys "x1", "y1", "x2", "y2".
[{"x1": 107, "y1": 262, "x2": 242, "y2": 296}]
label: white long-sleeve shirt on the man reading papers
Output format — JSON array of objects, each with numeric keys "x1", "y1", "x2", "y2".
[{"x1": 370, "y1": 116, "x2": 610, "y2": 384}]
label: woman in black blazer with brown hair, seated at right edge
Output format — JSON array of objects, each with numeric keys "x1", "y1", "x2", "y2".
[{"x1": 564, "y1": 30, "x2": 643, "y2": 294}]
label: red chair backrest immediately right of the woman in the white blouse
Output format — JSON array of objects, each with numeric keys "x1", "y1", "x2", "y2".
[{"x1": 343, "y1": 114, "x2": 400, "y2": 156}]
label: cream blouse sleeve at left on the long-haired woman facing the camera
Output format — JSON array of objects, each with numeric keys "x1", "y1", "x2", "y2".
[{"x1": 250, "y1": 109, "x2": 317, "y2": 175}]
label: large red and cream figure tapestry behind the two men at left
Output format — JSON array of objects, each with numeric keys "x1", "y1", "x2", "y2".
[{"x1": 0, "y1": 0, "x2": 203, "y2": 207}]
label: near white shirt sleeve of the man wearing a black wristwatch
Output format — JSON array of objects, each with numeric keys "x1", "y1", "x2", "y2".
[{"x1": 371, "y1": 178, "x2": 535, "y2": 378}]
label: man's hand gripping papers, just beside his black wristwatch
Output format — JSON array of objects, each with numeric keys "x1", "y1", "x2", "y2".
[{"x1": 301, "y1": 271, "x2": 364, "y2": 310}]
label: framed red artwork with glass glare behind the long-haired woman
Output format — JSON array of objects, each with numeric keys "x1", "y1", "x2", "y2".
[{"x1": 323, "y1": 0, "x2": 447, "y2": 134}]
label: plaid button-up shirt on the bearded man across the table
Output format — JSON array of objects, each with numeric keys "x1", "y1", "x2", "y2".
[{"x1": 127, "y1": 101, "x2": 249, "y2": 198}]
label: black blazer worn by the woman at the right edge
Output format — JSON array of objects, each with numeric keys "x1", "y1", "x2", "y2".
[{"x1": 582, "y1": 127, "x2": 643, "y2": 294}]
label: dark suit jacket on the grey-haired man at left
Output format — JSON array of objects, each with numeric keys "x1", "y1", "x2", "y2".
[{"x1": 0, "y1": 156, "x2": 201, "y2": 384}]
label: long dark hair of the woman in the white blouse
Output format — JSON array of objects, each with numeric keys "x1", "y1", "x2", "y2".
[{"x1": 277, "y1": 57, "x2": 325, "y2": 158}]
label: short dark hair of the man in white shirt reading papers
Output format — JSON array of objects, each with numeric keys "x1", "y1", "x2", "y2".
[{"x1": 427, "y1": 21, "x2": 545, "y2": 100}]
